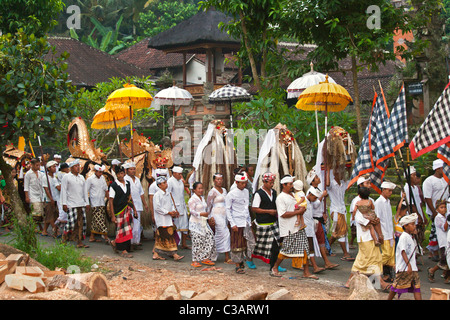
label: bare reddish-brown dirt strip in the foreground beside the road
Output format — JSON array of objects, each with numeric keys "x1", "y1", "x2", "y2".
[{"x1": 98, "y1": 256, "x2": 349, "y2": 300}]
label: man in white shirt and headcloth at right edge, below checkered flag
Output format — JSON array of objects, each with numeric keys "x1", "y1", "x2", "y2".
[{"x1": 422, "y1": 159, "x2": 449, "y2": 262}]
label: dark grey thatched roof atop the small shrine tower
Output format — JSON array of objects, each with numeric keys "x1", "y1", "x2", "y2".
[{"x1": 148, "y1": 9, "x2": 240, "y2": 53}]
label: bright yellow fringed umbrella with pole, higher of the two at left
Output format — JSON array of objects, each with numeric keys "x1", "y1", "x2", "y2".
[{"x1": 105, "y1": 83, "x2": 153, "y2": 159}]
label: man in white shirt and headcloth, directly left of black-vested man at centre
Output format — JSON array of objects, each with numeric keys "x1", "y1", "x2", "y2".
[{"x1": 225, "y1": 172, "x2": 256, "y2": 274}]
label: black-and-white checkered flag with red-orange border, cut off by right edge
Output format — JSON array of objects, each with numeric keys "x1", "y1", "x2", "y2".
[{"x1": 409, "y1": 83, "x2": 450, "y2": 160}]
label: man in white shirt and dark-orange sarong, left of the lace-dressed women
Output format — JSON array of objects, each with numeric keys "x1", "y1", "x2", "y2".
[{"x1": 153, "y1": 176, "x2": 184, "y2": 261}]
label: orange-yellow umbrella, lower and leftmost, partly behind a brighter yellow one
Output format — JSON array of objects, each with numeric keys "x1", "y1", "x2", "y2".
[{"x1": 91, "y1": 106, "x2": 130, "y2": 162}]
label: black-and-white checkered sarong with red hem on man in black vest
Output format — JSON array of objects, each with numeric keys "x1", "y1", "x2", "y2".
[{"x1": 252, "y1": 222, "x2": 280, "y2": 263}]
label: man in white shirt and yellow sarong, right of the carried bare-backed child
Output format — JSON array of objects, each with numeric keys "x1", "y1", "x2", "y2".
[{"x1": 375, "y1": 181, "x2": 396, "y2": 279}]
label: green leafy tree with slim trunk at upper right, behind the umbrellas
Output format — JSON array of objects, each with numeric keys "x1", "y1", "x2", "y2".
[{"x1": 280, "y1": 0, "x2": 409, "y2": 141}]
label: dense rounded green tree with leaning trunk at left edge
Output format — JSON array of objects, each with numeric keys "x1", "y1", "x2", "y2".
[{"x1": 0, "y1": 29, "x2": 75, "y2": 222}]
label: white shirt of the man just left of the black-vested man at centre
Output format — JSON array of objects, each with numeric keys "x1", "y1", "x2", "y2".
[{"x1": 225, "y1": 188, "x2": 251, "y2": 227}]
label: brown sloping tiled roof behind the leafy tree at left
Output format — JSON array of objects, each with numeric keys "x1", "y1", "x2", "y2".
[{"x1": 46, "y1": 37, "x2": 149, "y2": 86}]
